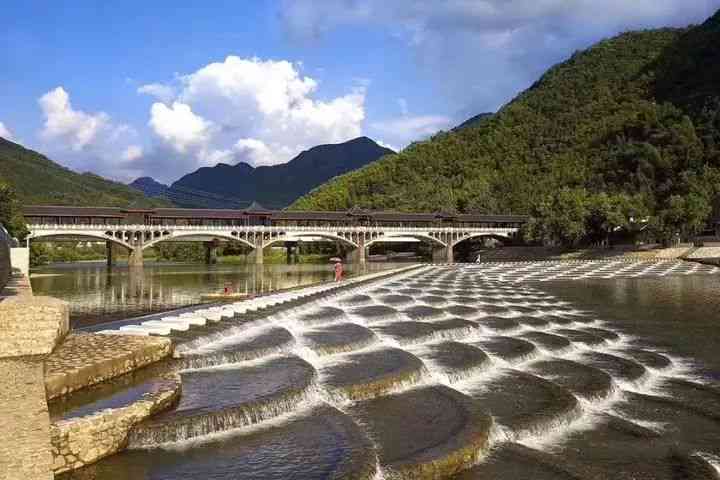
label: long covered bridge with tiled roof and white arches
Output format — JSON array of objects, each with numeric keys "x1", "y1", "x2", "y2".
[{"x1": 23, "y1": 205, "x2": 527, "y2": 267}]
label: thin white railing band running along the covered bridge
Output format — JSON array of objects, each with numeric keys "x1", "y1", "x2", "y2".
[{"x1": 28, "y1": 224, "x2": 518, "y2": 233}]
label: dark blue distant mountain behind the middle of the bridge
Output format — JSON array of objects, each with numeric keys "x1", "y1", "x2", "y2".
[{"x1": 169, "y1": 137, "x2": 394, "y2": 208}]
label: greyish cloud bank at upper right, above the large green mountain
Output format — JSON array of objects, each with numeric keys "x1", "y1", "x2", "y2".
[{"x1": 281, "y1": 0, "x2": 720, "y2": 114}]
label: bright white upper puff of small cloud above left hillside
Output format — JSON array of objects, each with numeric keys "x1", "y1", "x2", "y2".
[{"x1": 39, "y1": 87, "x2": 110, "y2": 151}]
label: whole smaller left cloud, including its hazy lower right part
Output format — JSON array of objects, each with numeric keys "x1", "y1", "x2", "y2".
[{"x1": 38, "y1": 86, "x2": 143, "y2": 181}]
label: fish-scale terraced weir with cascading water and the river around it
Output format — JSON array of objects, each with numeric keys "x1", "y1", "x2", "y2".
[{"x1": 51, "y1": 263, "x2": 720, "y2": 480}]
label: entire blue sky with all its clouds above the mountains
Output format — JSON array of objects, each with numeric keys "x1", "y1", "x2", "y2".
[{"x1": 0, "y1": 0, "x2": 720, "y2": 181}]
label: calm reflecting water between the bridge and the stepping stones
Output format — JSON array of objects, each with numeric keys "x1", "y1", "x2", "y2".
[{"x1": 31, "y1": 262, "x2": 404, "y2": 327}]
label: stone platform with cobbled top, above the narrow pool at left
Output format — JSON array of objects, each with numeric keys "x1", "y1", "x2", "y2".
[{"x1": 45, "y1": 333, "x2": 173, "y2": 399}]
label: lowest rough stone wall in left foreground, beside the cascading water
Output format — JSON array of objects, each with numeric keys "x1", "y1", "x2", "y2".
[{"x1": 50, "y1": 375, "x2": 181, "y2": 474}]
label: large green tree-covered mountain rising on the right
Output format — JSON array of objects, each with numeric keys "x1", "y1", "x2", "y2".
[{"x1": 291, "y1": 12, "x2": 720, "y2": 248}]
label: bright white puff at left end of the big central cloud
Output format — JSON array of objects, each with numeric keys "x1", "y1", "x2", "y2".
[{"x1": 148, "y1": 102, "x2": 212, "y2": 153}]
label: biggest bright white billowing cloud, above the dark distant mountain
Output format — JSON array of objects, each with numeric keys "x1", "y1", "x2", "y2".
[{"x1": 139, "y1": 56, "x2": 366, "y2": 177}]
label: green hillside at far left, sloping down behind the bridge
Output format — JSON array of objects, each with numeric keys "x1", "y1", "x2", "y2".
[{"x1": 0, "y1": 138, "x2": 168, "y2": 207}]
